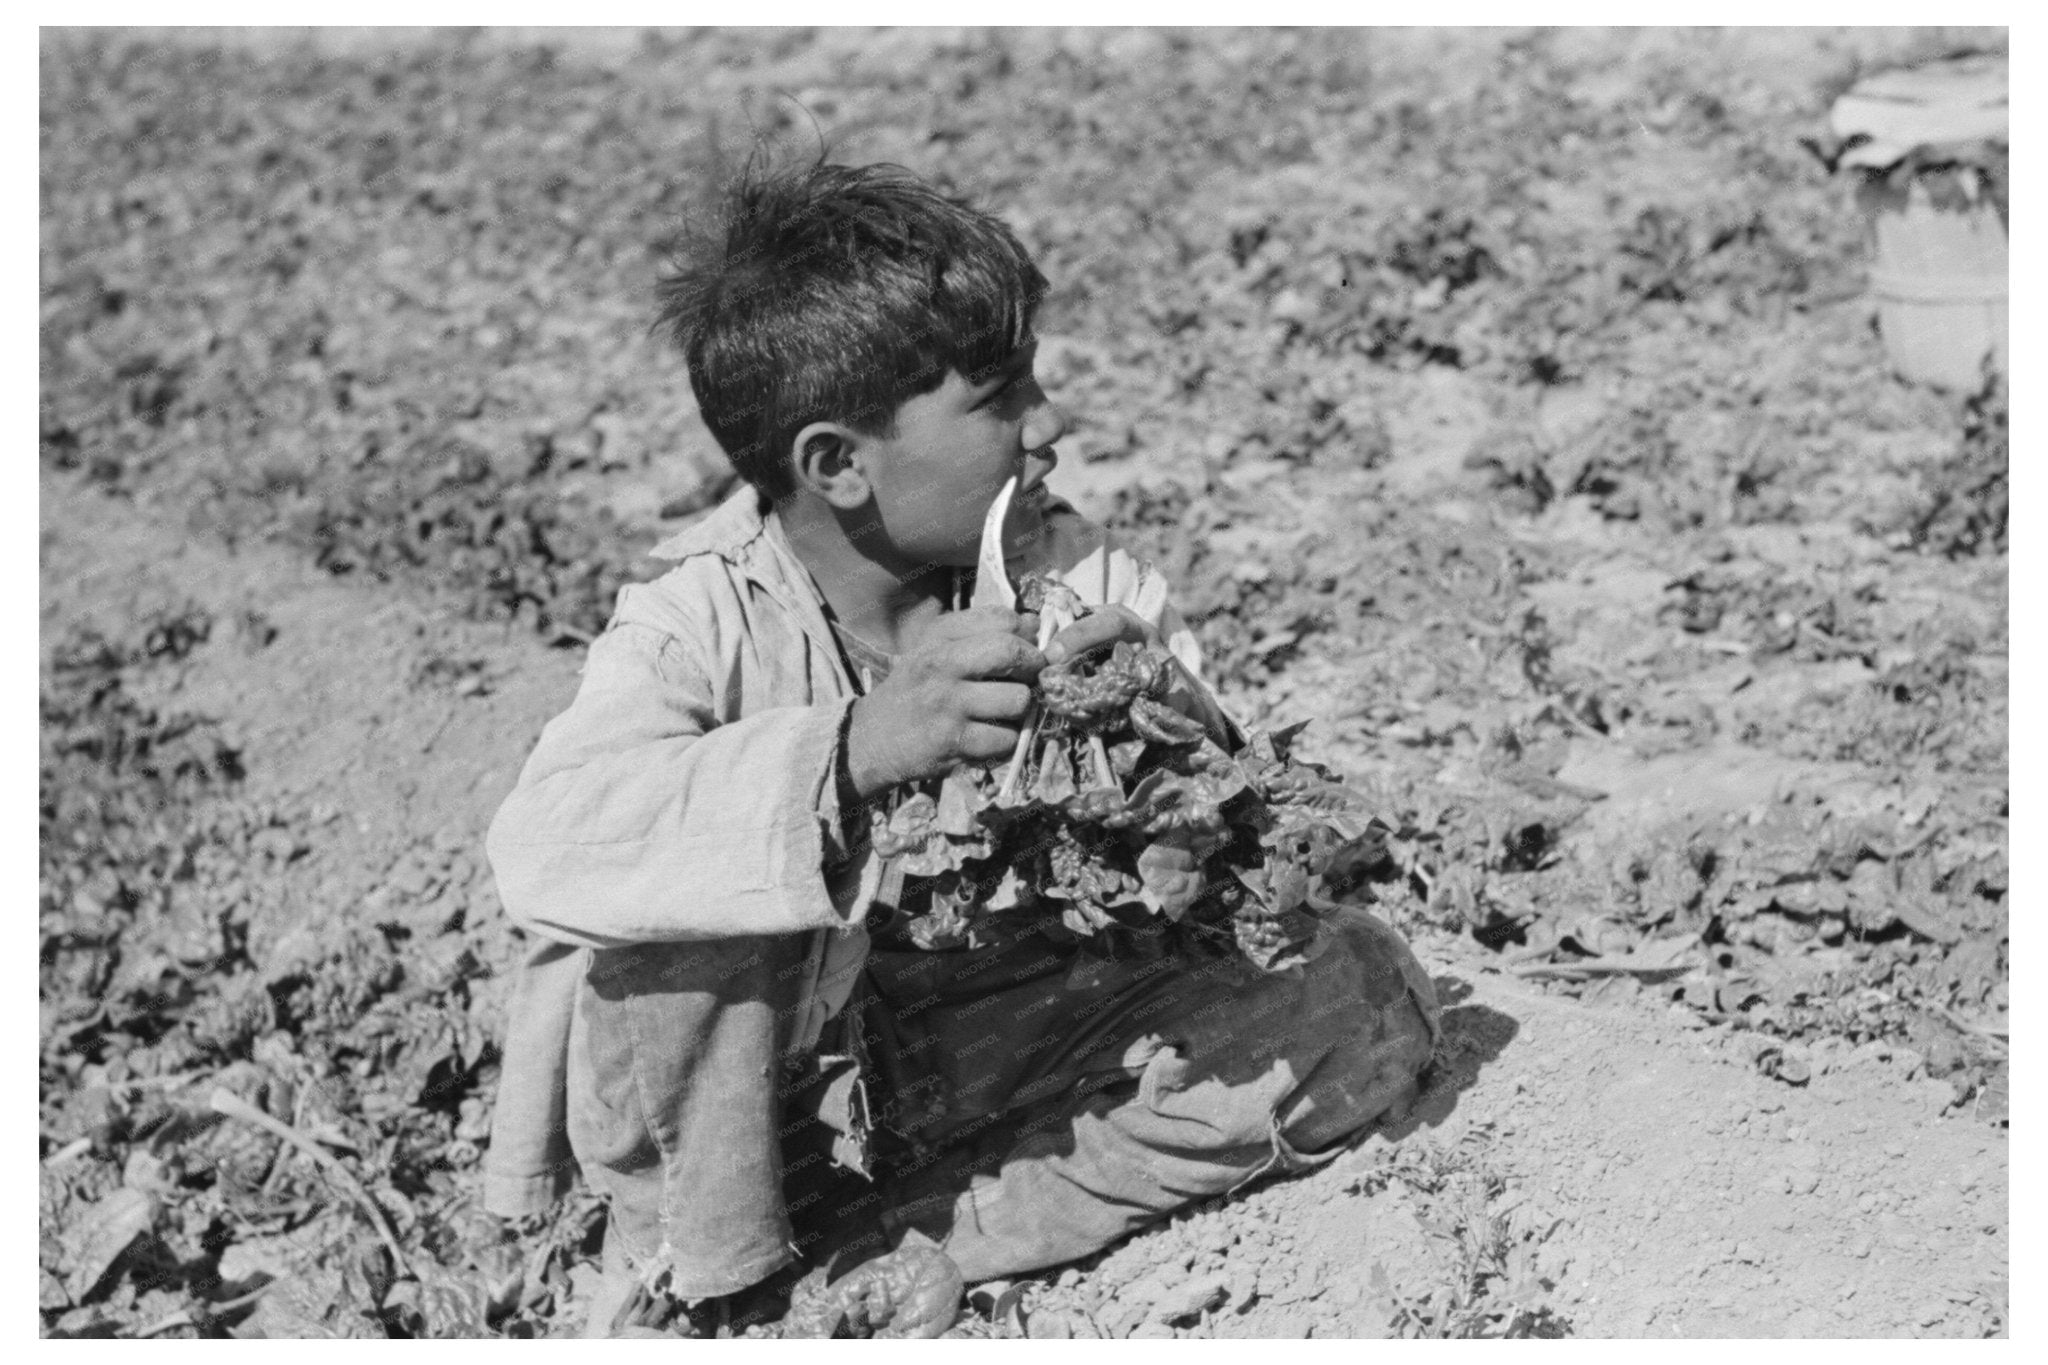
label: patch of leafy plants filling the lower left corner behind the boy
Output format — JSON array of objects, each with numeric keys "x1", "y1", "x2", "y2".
[{"x1": 39, "y1": 608, "x2": 516, "y2": 1336}]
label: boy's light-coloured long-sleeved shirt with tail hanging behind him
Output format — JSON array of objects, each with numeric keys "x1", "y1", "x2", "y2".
[{"x1": 485, "y1": 487, "x2": 1200, "y2": 1216}]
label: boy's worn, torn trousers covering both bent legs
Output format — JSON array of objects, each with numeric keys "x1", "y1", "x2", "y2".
[{"x1": 569, "y1": 909, "x2": 1438, "y2": 1297}]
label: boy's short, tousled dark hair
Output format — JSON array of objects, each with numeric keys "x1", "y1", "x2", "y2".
[{"x1": 655, "y1": 160, "x2": 1047, "y2": 499}]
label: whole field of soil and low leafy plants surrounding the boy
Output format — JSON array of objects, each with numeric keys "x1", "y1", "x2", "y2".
[{"x1": 39, "y1": 31, "x2": 2009, "y2": 1336}]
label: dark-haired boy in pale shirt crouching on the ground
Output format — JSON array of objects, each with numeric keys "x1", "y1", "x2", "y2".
[{"x1": 487, "y1": 164, "x2": 1436, "y2": 1334}]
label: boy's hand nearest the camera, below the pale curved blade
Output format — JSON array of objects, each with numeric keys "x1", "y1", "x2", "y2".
[{"x1": 846, "y1": 606, "x2": 1044, "y2": 800}]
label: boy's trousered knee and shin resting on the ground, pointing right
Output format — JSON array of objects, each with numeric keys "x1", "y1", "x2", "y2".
[{"x1": 880, "y1": 911, "x2": 1438, "y2": 1281}]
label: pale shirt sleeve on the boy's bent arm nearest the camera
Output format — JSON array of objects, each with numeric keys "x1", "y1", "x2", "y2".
[{"x1": 485, "y1": 622, "x2": 879, "y2": 948}]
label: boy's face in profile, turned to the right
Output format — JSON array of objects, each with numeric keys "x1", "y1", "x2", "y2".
[{"x1": 862, "y1": 342, "x2": 1067, "y2": 569}]
